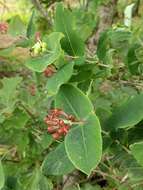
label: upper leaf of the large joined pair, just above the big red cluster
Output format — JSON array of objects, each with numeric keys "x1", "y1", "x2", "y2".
[{"x1": 55, "y1": 84, "x2": 94, "y2": 119}]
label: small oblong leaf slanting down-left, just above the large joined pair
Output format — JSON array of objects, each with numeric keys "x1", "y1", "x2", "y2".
[{"x1": 46, "y1": 63, "x2": 74, "y2": 95}]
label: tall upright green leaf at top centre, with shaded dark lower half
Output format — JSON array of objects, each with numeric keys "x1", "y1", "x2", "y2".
[{"x1": 55, "y1": 3, "x2": 84, "y2": 56}]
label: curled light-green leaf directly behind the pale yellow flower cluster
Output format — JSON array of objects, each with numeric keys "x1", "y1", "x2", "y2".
[{"x1": 26, "y1": 32, "x2": 64, "y2": 72}]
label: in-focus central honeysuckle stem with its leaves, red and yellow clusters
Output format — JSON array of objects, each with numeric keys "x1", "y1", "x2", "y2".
[{"x1": 26, "y1": 3, "x2": 102, "y2": 175}]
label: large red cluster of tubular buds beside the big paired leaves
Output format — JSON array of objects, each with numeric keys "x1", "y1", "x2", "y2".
[{"x1": 44, "y1": 109, "x2": 75, "y2": 140}]
